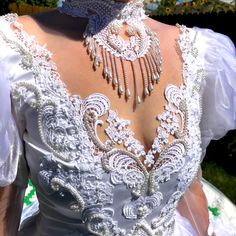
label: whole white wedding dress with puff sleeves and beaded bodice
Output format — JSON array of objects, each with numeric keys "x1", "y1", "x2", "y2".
[{"x1": 0, "y1": 14, "x2": 236, "y2": 236}]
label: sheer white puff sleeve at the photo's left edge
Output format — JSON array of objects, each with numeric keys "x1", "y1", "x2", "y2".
[{"x1": 0, "y1": 63, "x2": 22, "y2": 186}]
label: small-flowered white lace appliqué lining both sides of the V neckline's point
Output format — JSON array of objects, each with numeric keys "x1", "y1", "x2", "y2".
[{"x1": 105, "y1": 85, "x2": 185, "y2": 167}]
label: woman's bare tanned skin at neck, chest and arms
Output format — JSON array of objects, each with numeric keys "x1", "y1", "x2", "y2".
[{"x1": 0, "y1": 0, "x2": 208, "y2": 236}]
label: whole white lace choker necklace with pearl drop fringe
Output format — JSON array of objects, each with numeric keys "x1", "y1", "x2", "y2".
[{"x1": 59, "y1": 0, "x2": 162, "y2": 104}]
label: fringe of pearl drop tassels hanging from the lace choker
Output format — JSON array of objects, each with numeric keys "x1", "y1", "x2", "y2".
[{"x1": 85, "y1": 31, "x2": 162, "y2": 104}]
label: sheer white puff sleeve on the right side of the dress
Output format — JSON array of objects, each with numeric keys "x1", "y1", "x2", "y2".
[{"x1": 195, "y1": 28, "x2": 236, "y2": 153}]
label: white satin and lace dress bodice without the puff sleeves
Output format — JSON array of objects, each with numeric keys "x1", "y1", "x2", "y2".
[{"x1": 0, "y1": 15, "x2": 203, "y2": 236}]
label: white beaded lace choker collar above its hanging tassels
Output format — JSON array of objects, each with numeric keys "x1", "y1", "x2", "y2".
[{"x1": 59, "y1": 0, "x2": 148, "y2": 60}]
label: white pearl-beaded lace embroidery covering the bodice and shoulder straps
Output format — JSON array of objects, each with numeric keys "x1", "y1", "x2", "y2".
[{"x1": 0, "y1": 15, "x2": 205, "y2": 236}]
